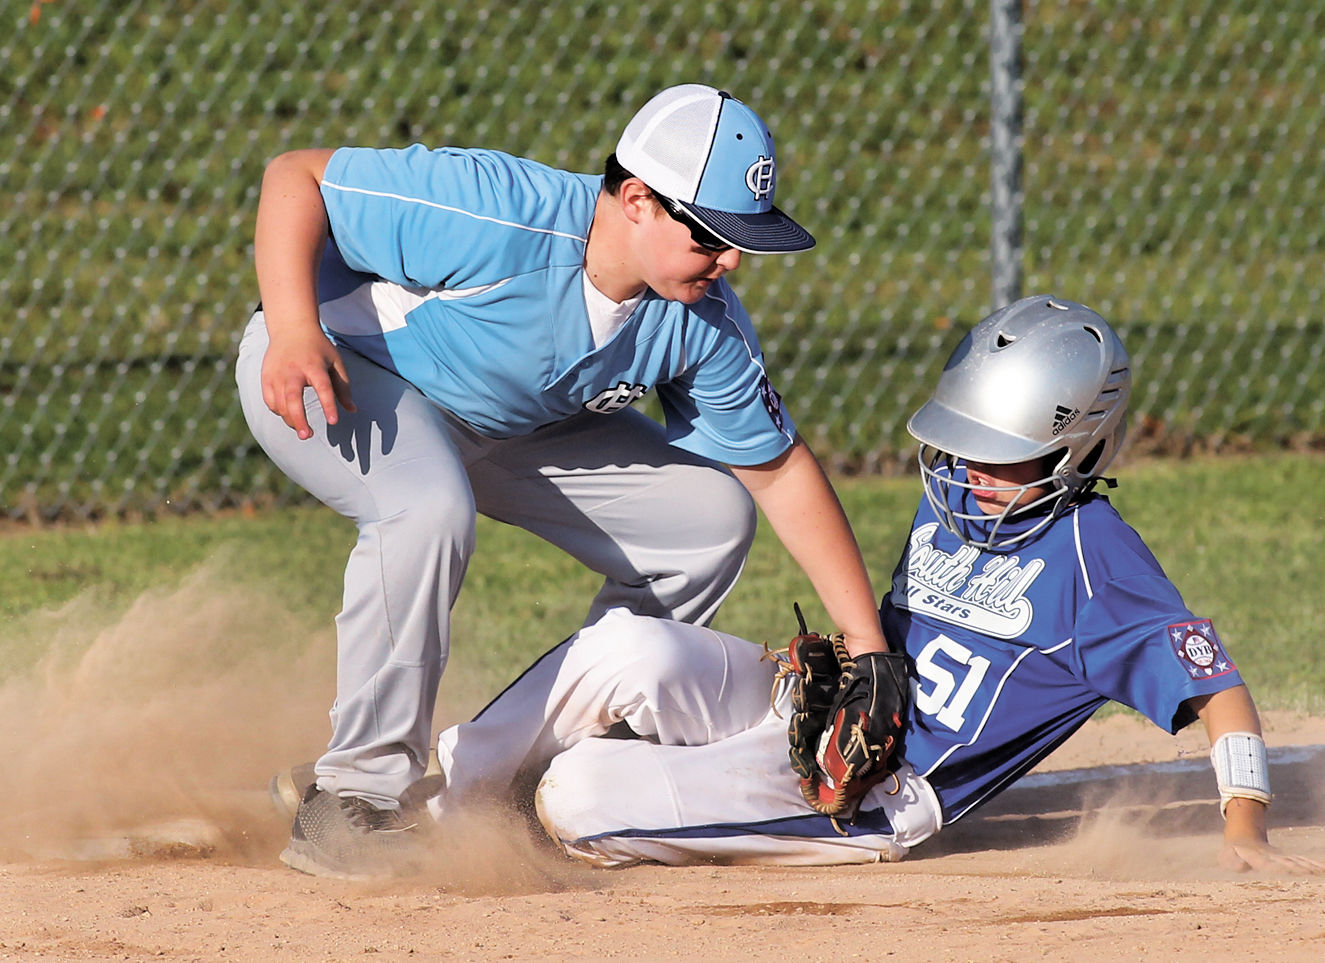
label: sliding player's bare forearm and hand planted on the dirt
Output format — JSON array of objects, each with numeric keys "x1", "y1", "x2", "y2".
[{"x1": 1190, "y1": 685, "x2": 1325, "y2": 873}]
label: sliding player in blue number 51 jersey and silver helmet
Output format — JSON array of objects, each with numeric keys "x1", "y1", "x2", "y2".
[{"x1": 416, "y1": 295, "x2": 1325, "y2": 873}]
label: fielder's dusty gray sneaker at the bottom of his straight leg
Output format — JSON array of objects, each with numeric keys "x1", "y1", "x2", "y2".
[{"x1": 281, "y1": 783, "x2": 423, "y2": 880}]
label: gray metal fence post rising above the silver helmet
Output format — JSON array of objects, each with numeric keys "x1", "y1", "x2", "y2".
[{"x1": 990, "y1": 0, "x2": 1024, "y2": 310}]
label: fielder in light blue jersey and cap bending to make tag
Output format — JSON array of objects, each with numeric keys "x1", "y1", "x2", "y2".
[{"x1": 237, "y1": 85, "x2": 885, "y2": 874}]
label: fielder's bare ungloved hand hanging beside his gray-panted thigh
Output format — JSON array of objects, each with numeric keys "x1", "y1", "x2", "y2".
[{"x1": 255, "y1": 329, "x2": 356, "y2": 440}]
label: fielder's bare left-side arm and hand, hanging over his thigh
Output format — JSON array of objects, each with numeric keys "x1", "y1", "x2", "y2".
[{"x1": 253, "y1": 150, "x2": 354, "y2": 438}]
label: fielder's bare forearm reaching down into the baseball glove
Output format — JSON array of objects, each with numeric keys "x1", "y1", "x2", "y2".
[{"x1": 731, "y1": 437, "x2": 888, "y2": 656}]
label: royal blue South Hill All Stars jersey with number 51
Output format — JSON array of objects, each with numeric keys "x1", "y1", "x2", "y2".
[{"x1": 881, "y1": 486, "x2": 1242, "y2": 823}]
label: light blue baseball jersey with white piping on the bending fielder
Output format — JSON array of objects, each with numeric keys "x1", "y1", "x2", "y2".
[{"x1": 307, "y1": 144, "x2": 795, "y2": 465}]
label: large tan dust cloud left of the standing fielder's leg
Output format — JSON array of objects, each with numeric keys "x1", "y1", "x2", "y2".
[{"x1": 0, "y1": 566, "x2": 335, "y2": 856}]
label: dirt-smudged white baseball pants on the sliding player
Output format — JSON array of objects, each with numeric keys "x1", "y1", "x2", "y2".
[{"x1": 429, "y1": 611, "x2": 942, "y2": 866}]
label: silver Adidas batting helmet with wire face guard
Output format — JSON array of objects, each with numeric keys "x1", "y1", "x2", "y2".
[{"x1": 906, "y1": 294, "x2": 1132, "y2": 550}]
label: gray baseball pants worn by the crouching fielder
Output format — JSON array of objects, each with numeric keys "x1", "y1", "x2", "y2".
[{"x1": 236, "y1": 313, "x2": 755, "y2": 807}]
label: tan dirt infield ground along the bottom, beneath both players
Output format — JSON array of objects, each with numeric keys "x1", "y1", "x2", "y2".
[{"x1": 0, "y1": 717, "x2": 1325, "y2": 963}]
